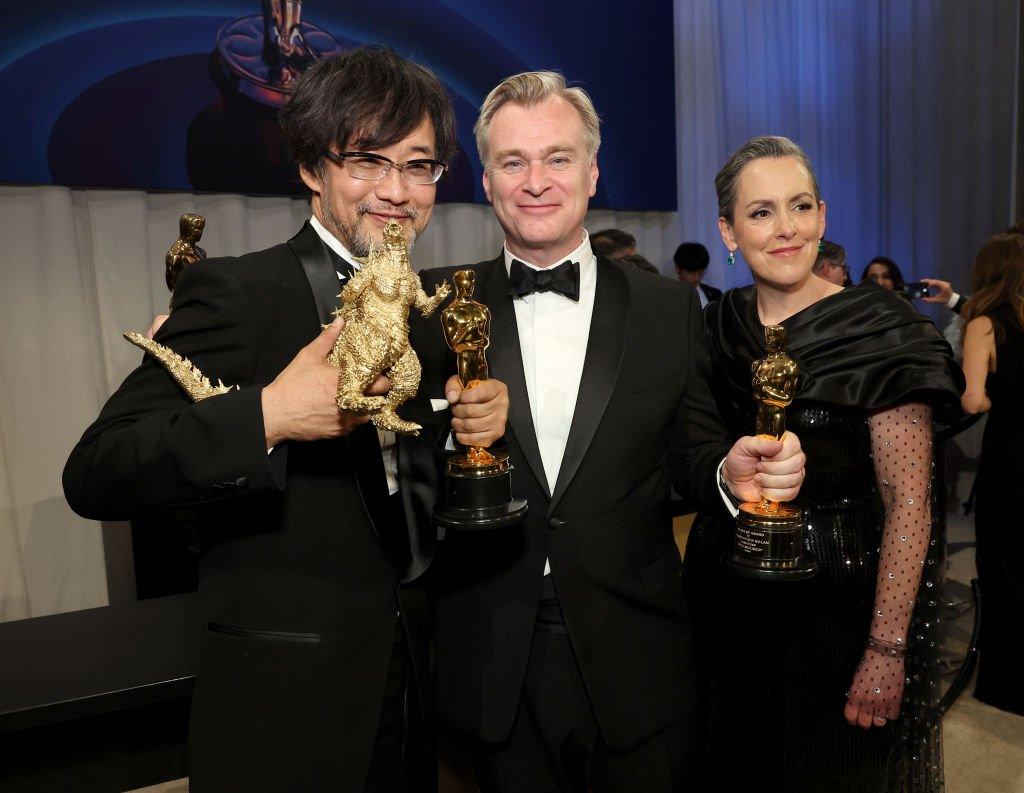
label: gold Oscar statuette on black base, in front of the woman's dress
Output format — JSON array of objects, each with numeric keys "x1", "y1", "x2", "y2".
[{"x1": 726, "y1": 325, "x2": 817, "y2": 581}]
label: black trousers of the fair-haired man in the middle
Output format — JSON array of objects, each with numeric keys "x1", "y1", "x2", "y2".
[{"x1": 470, "y1": 601, "x2": 700, "y2": 793}]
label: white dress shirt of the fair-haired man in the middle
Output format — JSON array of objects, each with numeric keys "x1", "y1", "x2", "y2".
[{"x1": 505, "y1": 231, "x2": 597, "y2": 575}]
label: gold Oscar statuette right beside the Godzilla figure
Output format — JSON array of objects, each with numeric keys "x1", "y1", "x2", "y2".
[{"x1": 434, "y1": 269, "x2": 526, "y2": 529}]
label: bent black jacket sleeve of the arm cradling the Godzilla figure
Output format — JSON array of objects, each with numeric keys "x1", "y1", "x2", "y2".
[{"x1": 63, "y1": 259, "x2": 287, "y2": 519}]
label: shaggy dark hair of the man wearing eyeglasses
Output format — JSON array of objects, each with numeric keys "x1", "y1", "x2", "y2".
[{"x1": 280, "y1": 46, "x2": 456, "y2": 180}]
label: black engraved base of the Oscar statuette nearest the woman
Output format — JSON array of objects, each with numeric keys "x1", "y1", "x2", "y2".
[{"x1": 723, "y1": 502, "x2": 818, "y2": 581}]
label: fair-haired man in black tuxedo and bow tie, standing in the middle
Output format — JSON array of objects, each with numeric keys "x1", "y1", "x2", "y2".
[{"x1": 414, "y1": 72, "x2": 803, "y2": 793}]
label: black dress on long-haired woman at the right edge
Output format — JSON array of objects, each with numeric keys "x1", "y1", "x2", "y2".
[{"x1": 974, "y1": 306, "x2": 1024, "y2": 715}]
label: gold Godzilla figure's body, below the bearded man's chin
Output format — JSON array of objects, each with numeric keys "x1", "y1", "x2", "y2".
[{"x1": 327, "y1": 220, "x2": 451, "y2": 435}]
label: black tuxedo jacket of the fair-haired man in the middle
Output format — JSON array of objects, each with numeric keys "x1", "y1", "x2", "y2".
[{"x1": 414, "y1": 256, "x2": 728, "y2": 749}]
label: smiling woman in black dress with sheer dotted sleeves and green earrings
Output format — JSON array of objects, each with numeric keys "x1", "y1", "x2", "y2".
[{"x1": 684, "y1": 137, "x2": 963, "y2": 793}]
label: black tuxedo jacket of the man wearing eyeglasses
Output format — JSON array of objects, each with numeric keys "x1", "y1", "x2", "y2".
[{"x1": 63, "y1": 224, "x2": 444, "y2": 791}]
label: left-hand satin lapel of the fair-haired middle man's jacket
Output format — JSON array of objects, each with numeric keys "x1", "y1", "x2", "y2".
[{"x1": 476, "y1": 255, "x2": 551, "y2": 495}]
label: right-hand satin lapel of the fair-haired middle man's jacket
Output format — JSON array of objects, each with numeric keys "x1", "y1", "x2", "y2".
[{"x1": 551, "y1": 257, "x2": 630, "y2": 509}]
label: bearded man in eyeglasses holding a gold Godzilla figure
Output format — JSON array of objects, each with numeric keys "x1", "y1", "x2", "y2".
[{"x1": 65, "y1": 47, "x2": 507, "y2": 793}]
